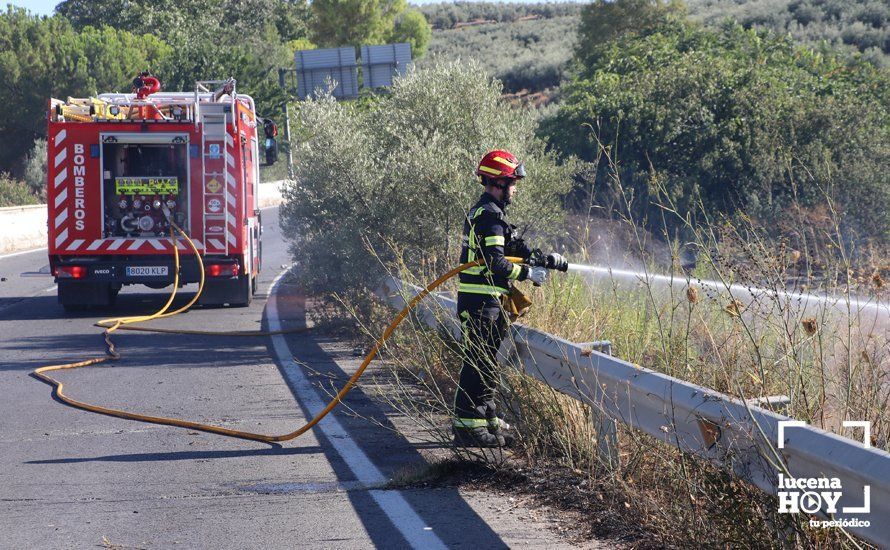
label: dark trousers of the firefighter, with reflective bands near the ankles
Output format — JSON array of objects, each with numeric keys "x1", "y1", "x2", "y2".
[{"x1": 454, "y1": 299, "x2": 507, "y2": 427}]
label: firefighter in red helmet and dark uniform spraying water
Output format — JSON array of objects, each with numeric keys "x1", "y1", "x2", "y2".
[{"x1": 453, "y1": 150, "x2": 568, "y2": 447}]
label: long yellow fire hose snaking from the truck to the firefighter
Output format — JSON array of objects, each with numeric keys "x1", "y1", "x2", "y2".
[{"x1": 32, "y1": 221, "x2": 523, "y2": 443}]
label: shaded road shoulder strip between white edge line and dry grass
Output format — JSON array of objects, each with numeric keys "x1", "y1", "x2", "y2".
[{"x1": 278, "y1": 278, "x2": 616, "y2": 548}]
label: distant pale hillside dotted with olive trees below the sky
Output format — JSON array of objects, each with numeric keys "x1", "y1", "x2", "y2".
[{"x1": 417, "y1": 0, "x2": 890, "y2": 99}]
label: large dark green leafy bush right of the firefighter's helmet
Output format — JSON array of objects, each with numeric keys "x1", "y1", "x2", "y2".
[{"x1": 543, "y1": 17, "x2": 890, "y2": 246}]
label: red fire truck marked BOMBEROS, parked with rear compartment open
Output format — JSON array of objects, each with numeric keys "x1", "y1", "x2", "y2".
[{"x1": 47, "y1": 73, "x2": 261, "y2": 310}]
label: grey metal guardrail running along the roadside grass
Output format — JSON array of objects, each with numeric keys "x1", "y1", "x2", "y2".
[{"x1": 378, "y1": 278, "x2": 890, "y2": 547}]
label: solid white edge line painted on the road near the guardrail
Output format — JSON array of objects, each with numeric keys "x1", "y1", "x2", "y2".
[{"x1": 266, "y1": 270, "x2": 446, "y2": 550}]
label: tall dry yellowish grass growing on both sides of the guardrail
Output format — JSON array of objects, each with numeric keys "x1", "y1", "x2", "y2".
[{"x1": 344, "y1": 202, "x2": 890, "y2": 547}]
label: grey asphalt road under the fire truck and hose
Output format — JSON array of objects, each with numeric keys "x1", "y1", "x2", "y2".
[{"x1": 0, "y1": 208, "x2": 584, "y2": 548}]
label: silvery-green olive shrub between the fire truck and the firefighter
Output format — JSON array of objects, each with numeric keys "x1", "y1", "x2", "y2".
[{"x1": 281, "y1": 63, "x2": 573, "y2": 310}]
